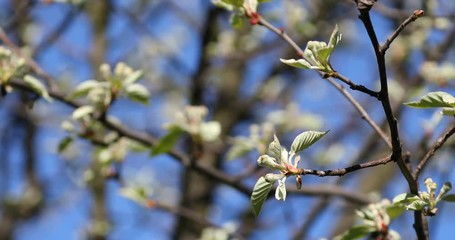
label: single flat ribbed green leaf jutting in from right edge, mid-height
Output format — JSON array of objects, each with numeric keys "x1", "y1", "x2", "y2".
[{"x1": 405, "y1": 92, "x2": 455, "y2": 108}]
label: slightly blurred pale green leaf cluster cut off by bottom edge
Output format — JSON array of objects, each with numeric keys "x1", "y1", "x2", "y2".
[{"x1": 334, "y1": 199, "x2": 402, "y2": 240}]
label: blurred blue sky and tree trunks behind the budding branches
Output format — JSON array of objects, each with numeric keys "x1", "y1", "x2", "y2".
[{"x1": 0, "y1": 0, "x2": 455, "y2": 239}]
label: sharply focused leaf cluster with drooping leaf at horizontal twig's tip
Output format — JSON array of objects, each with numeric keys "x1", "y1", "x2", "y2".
[{"x1": 251, "y1": 131, "x2": 327, "y2": 215}]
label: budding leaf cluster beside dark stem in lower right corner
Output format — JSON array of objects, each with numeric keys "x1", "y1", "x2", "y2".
[{"x1": 393, "y1": 178, "x2": 454, "y2": 216}]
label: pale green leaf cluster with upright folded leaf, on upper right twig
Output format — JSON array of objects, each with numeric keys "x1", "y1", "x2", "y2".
[{"x1": 280, "y1": 26, "x2": 341, "y2": 74}]
